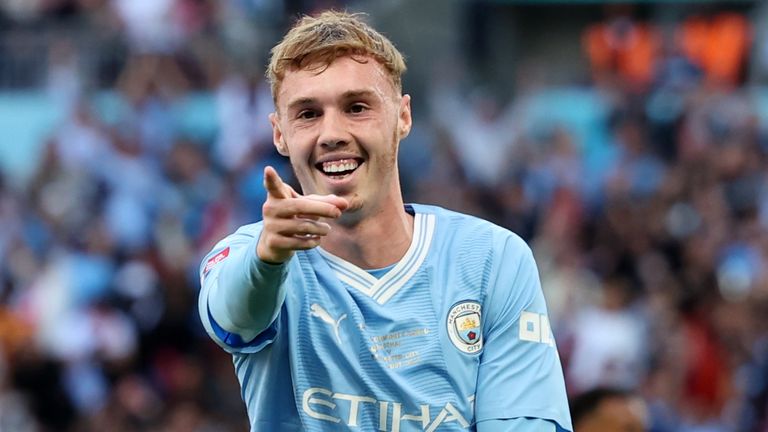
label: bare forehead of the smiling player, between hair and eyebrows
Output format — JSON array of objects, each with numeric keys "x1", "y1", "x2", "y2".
[{"x1": 276, "y1": 56, "x2": 396, "y2": 108}]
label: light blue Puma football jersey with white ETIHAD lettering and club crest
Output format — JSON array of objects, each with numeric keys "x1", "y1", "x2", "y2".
[{"x1": 200, "y1": 204, "x2": 572, "y2": 431}]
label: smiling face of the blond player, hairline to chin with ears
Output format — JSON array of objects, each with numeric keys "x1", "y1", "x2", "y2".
[{"x1": 270, "y1": 56, "x2": 411, "y2": 218}]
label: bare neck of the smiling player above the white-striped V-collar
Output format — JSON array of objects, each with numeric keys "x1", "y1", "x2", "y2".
[{"x1": 322, "y1": 200, "x2": 413, "y2": 269}]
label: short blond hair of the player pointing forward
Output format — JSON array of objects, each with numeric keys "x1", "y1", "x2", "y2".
[{"x1": 266, "y1": 11, "x2": 405, "y2": 100}]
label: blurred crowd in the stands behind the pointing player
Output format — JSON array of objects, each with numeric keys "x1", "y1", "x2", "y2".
[{"x1": 0, "y1": 0, "x2": 768, "y2": 432}]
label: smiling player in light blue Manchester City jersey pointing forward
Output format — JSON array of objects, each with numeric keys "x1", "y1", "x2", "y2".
[{"x1": 199, "y1": 12, "x2": 572, "y2": 432}]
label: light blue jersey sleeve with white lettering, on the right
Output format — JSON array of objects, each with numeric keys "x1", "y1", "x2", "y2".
[{"x1": 475, "y1": 234, "x2": 572, "y2": 430}]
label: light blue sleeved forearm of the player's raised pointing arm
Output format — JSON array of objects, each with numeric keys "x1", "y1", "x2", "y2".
[{"x1": 208, "y1": 236, "x2": 288, "y2": 341}]
